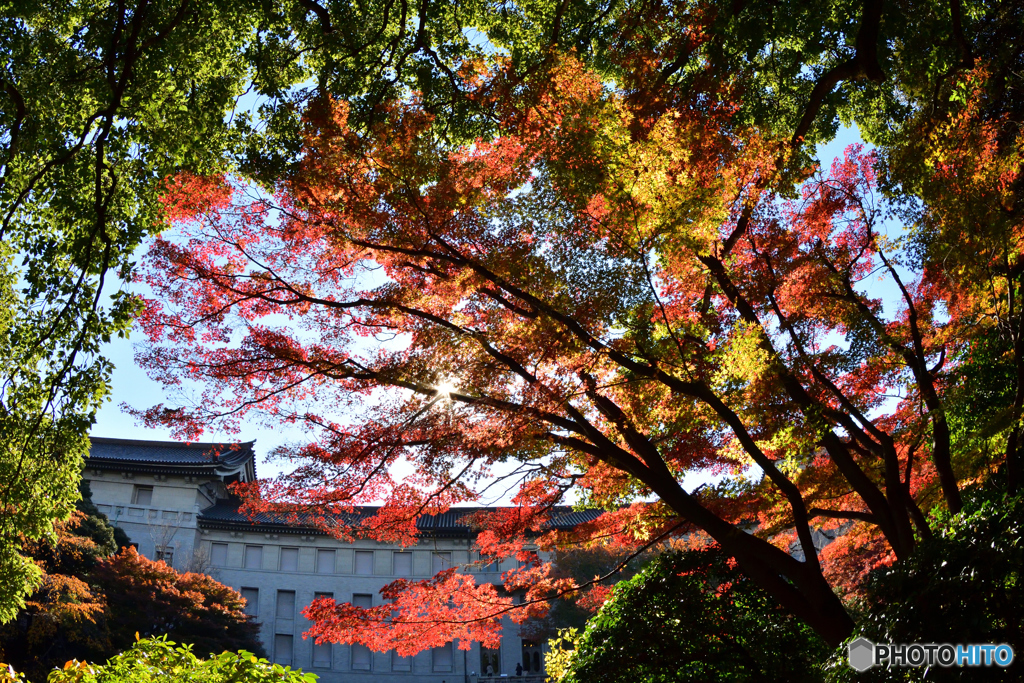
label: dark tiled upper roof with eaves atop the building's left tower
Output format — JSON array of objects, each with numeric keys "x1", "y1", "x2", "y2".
[{"x1": 85, "y1": 436, "x2": 256, "y2": 481}]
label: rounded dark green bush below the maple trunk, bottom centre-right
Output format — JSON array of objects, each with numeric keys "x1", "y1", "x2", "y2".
[{"x1": 549, "y1": 550, "x2": 827, "y2": 683}]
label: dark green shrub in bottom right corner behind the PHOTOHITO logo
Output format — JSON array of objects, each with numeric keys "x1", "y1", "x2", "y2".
[{"x1": 827, "y1": 485, "x2": 1024, "y2": 682}]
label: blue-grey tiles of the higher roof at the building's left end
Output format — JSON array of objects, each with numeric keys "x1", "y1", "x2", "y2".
[{"x1": 89, "y1": 436, "x2": 255, "y2": 467}]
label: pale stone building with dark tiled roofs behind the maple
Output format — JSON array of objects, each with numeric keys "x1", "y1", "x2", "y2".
[{"x1": 84, "y1": 438, "x2": 596, "y2": 683}]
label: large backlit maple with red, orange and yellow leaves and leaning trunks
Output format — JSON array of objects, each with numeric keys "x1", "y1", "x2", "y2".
[{"x1": 130, "y1": 3, "x2": 1020, "y2": 654}]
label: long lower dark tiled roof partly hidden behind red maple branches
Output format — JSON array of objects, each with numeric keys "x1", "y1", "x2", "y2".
[{"x1": 199, "y1": 500, "x2": 603, "y2": 538}]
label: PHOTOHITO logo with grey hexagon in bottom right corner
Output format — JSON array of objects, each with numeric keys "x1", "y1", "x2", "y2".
[{"x1": 848, "y1": 638, "x2": 1014, "y2": 671}]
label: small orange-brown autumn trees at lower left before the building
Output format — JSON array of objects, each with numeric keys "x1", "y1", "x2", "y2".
[{"x1": 0, "y1": 486, "x2": 261, "y2": 681}]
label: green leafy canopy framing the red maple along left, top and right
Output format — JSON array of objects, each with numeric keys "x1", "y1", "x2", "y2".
[{"x1": 0, "y1": 0, "x2": 1024, "y2": 651}]
